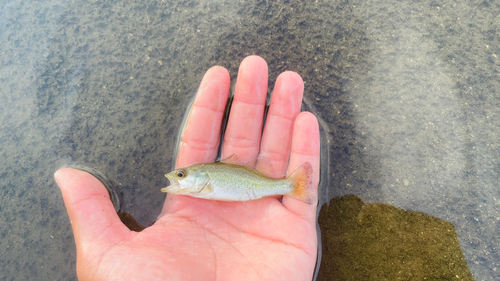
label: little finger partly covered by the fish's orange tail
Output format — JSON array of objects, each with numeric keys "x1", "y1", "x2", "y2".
[{"x1": 282, "y1": 112, "x2": 320, "y2": 218}]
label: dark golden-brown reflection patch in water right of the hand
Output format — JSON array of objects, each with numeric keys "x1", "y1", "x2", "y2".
[{"x1": 317, "y1": 195, "x2": 474, "y2": 280}]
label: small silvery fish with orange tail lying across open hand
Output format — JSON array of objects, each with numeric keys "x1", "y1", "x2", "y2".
[{"x1": 161, "y1": 157, "x2": 316, "y2": 204}]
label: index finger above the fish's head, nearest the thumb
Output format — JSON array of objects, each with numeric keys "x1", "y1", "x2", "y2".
[{"x1": 177, "y1": 66, "x2": 229, "y2": 167}]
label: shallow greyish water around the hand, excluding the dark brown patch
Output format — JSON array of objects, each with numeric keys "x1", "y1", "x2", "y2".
[{"x1": 0, "y1": 0, "x2": 500, "y2": 280}]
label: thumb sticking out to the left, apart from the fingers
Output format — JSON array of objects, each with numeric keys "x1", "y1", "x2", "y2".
[{"x1": 54, "y1": 168, "x2": 131, "y2": 249}]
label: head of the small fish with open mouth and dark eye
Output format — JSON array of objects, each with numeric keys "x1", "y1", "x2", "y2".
[{"x1": 161, "y1": 165, "x2": 210, "y2": 195}]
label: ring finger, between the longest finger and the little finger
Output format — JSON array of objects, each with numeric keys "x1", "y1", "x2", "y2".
[{"x1": 257, "y1": 71, "x2": 304, "y2": 178}]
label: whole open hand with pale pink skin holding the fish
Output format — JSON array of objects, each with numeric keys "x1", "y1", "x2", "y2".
[{"x1": 55, "y1": 56, "x2": 320, "y2": 280}]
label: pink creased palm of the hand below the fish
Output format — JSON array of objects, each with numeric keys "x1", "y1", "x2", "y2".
[{"x1": 80, "y1": 196, "x2": 316, "y2": 280}]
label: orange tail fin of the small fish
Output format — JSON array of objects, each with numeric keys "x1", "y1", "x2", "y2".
[{"x1": 286, "y1": 162, "x2": 316, "y2": 205}]
